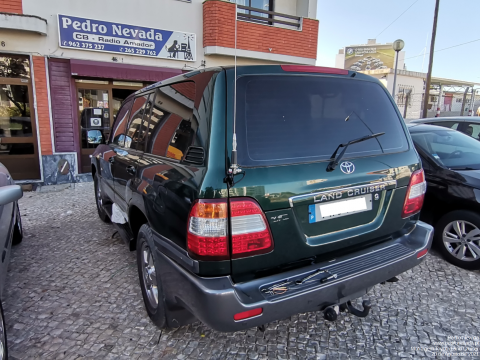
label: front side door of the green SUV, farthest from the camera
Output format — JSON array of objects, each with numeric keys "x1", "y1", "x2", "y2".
[{"x1": 100, "y1": 98, "x2": 133, "y2": 200}]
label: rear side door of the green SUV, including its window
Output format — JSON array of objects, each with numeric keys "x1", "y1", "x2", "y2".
[{"x1": 110, "y1": 93, "x2": 153, "y2": 212}]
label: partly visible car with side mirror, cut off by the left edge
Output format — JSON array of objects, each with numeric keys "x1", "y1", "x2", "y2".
[{"x1": 0, "y1": 163, "x2": 23, "y2": 359}]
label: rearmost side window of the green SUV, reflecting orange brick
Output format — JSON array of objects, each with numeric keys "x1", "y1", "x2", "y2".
[{"x1": 147, "y1": 82, "x2": 198, "y2": 160}]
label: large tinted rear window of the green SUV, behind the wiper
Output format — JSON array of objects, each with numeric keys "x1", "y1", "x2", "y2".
[{"x1": 237, "y1": 75, "x2": 408, "y2": 166}]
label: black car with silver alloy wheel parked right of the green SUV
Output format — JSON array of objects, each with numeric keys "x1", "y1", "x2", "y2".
[{"x1": 409, "y1": 125, "x2": 480, "y2": 269}]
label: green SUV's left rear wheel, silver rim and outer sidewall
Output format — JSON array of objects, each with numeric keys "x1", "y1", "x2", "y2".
[{"x1": 137, "y1": 224, "x2": 167, "y2": 329}]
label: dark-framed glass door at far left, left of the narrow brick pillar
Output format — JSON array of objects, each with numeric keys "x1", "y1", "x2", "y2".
[{"x1": 0, "y1": 54, "x2": 40, "y2": 180}]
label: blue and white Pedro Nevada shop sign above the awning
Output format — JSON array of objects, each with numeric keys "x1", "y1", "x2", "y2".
[{"x1": 58, "y1": 14, "x2": 196, "y2": 61}]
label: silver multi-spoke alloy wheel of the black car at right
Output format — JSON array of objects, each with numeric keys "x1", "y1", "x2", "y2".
[{"x1": 442, "y1": 220, "x2": 480, "y2": 261}]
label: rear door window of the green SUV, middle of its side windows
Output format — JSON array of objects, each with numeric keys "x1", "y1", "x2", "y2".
[{"x1": 125, "y1": 94, "x2": 150, "y2": 151}]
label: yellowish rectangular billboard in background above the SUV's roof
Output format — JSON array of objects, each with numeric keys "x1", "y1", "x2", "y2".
[{"x1": 343, "y1": 44, "x2": 395, "y2": 71}]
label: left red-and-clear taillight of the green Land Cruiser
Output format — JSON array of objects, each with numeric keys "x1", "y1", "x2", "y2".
[{"x1": 187, "y1": 198, "x2": 273, "y2": 260}]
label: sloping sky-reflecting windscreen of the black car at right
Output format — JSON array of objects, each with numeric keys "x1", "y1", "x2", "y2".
[{"x1": 412, "y1": 130, "x2": 480, "y2": 170}]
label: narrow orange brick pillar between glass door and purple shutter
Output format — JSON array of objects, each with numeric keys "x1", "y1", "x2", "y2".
[{"x1": 33, "y1": 56, "x2": 53, "y2": 155}]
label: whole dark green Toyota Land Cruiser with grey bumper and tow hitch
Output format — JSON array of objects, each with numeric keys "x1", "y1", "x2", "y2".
[{"x1": 92, "y1": 65, "x2": 433, "y2": 331}]
